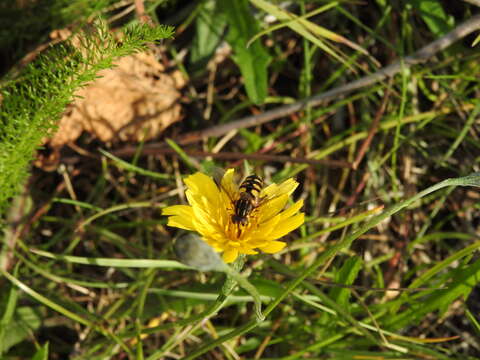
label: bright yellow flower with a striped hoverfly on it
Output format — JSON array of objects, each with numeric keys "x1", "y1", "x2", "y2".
[{"x1": 162, "y1": 169, "x2": 304, "y2": 263}]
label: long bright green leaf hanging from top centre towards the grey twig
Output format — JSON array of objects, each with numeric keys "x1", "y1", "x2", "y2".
[{"x1": 219, "y1": 0, "x2": 271, "y2": 104}]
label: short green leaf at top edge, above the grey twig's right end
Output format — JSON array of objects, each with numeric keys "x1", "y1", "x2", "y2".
[{"x1": 411, "y1": 0, "x2": 455, "y2": 37}]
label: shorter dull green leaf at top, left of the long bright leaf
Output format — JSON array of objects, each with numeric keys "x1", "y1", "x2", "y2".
[{"x1": 190, "y1": 0, "x2": 227, "y2": 69}]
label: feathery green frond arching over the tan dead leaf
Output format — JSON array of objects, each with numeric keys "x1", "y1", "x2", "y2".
[{"x1": 0, "y1": 24, "x2": 173, "y2": 222}]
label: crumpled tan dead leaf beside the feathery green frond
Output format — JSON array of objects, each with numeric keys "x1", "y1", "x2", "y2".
[{"x1": 35, "y1": 45, "x2": 185, "y2": 168}]
